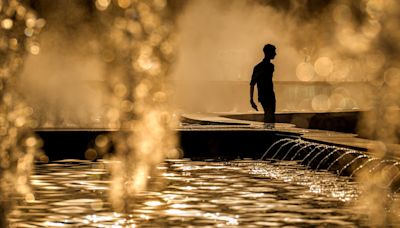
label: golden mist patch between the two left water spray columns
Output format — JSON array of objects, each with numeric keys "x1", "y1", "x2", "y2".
[{"x1": 21, "y1": 1, "x2": 105, "y2": 128}]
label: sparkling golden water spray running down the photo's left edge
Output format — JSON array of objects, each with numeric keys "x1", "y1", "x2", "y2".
[{"x1": 0, "y1": 0, "x2": 45, "y2": 227}]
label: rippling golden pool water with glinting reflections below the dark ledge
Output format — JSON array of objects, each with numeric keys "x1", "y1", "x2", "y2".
[{"x1": 9, "y1": 160, "x2": 366, "y2": 227}]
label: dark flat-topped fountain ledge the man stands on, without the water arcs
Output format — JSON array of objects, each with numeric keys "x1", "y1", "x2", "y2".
[{"x1": 36, "y1": 113, "x2": 400, "y2": 160}]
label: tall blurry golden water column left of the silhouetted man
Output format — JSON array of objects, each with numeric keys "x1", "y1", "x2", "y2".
[{"x1": 88, "y1": 1, "x2": 177, "y2": 212}]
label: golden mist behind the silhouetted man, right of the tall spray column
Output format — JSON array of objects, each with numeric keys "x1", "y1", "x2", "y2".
[{"x1": 169, "y1": 0, "x2": 394, "y2": 115}]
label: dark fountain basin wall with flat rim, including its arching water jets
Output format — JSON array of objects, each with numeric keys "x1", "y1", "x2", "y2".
[{"x1": 36, "y1": 114, "x2": 396, "y2": 181}]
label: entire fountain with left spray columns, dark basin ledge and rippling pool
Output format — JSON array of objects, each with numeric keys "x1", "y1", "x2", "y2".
[{"x1": 0, "y1": 0, "x2": 400, "y2": 227}]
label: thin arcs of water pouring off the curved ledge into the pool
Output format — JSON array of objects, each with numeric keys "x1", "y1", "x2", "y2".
[{"x1": 260, "y1": 138, "x2": 400, "y2": 190}]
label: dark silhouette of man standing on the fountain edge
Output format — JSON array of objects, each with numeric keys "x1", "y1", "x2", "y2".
[{"x1": 250, "y1": 44, "x2": 276, "y2": 123}]
